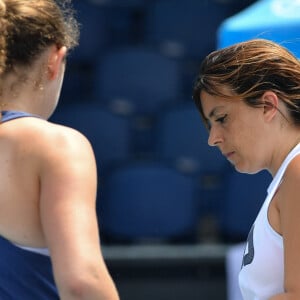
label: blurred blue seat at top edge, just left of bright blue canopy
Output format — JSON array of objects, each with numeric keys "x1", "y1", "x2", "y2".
[{"x1": 145, "y1": 0, "x2": 231, "y2": 59}]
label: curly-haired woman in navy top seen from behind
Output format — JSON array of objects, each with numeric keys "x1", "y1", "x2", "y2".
[{"x1": 0, "y1": 0, "x2": 119, "y2": 300}]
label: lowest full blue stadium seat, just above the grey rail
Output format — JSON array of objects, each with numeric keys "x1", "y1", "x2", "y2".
[{"x1": 98, "y1": 161, "x2": 198, "y2": 242}]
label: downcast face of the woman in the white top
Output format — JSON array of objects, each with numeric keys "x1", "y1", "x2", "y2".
[{"x1": 200, "y1": 91, "x2": 266, "y2": 173}]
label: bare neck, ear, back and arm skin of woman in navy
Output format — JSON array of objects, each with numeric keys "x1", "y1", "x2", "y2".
[{"x1": 0, "y1": 46, "x2": 119, "y2": 300}]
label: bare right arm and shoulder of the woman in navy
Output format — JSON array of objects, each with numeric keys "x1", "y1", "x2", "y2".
[{"x1": 40, "y1": 125, "x2": 119, "y2": 300}]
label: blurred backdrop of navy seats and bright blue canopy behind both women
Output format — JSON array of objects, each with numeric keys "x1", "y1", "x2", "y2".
[{"x1": 50, "y1": 0, "x2": 300, "y2": 300}]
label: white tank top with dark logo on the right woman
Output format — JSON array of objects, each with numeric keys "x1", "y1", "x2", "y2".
[{"x1": 239, "y1": 144, "x2": 300, "y2": 300}]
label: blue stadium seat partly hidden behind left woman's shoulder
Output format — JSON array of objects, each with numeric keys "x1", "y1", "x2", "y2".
[{"x1": 50, "y1": 104, "x2": 131, "y2": 173}]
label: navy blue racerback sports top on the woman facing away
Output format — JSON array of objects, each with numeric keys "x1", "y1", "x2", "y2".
[{"x1": 0, "y1": 111, "x2": 59, "y2": 300}]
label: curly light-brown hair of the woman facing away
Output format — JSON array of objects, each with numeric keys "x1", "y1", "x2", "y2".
[{"x1": 0, "y1": 0, "x2": 78, "y2": 75}]
